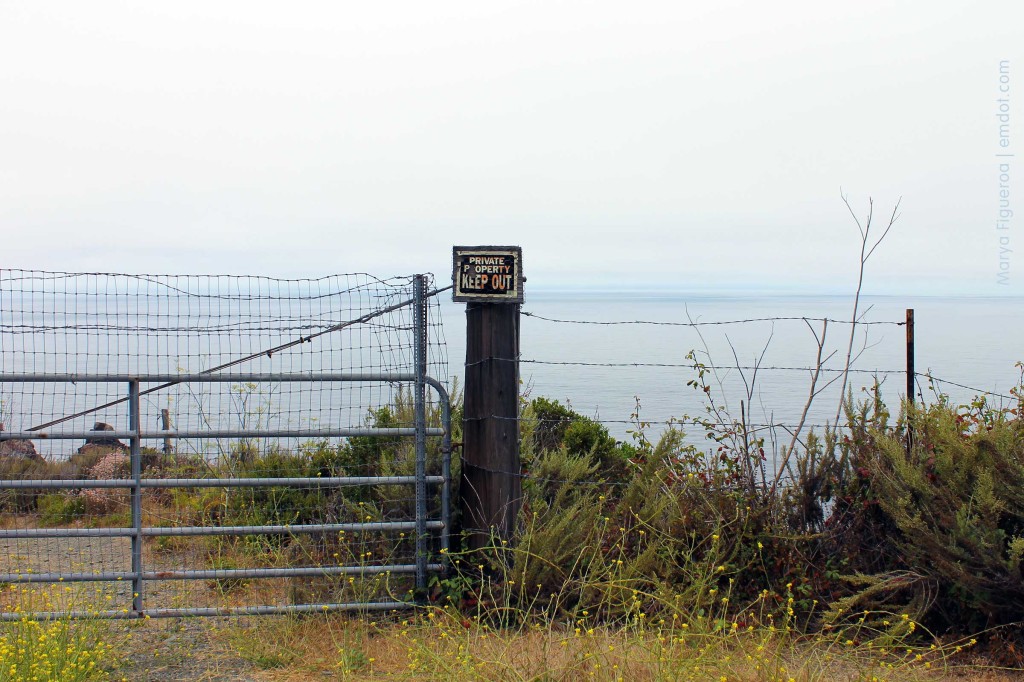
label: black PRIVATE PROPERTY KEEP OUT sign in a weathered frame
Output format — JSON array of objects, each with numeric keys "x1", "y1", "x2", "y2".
[{"x1": 452, "y1": 246, "x2": 523, "y2": 303}]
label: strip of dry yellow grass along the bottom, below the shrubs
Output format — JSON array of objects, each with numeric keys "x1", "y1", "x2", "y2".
[{"x1": 192, "y1": 609, "x2": 1024, "y2": 682}]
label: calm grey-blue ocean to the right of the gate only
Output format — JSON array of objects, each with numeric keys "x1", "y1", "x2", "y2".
[{"x1": 440, "y1": 291, "x2": 1024, "y2": 439}]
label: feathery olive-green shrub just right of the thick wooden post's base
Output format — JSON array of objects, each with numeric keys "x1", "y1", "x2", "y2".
[{"x1": 495, "y1": 422, "x2": 798, "y2": 619}]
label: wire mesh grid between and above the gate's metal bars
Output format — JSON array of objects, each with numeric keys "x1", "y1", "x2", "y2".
[{"x1": 0, "y1": 269, "x2": 447, "y2": 608}]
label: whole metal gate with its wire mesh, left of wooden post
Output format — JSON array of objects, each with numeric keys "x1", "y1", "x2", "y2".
[{"x1": 0, "y1": 270, "x2": 450, "y2": 617}]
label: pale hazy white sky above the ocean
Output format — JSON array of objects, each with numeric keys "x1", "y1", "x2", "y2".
[{"x1": 0, "y1": 0, "x2": 1024, "y2": 295}]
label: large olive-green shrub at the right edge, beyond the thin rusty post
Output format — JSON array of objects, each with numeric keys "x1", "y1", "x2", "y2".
[{"x1": 835, "y1": 398, "x2": 1024, "y2": 630}]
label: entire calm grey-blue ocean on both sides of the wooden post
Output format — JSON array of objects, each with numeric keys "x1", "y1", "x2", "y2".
[{"x1": 0, "y1": 270, "x2": 1024, "y2": 456}]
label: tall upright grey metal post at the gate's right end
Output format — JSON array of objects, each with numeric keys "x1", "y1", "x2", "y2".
[{"x1": 413, "y1": 274, "x2": 427, "y2": 591}]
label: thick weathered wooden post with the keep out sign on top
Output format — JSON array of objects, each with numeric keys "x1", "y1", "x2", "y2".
[{"x1": 453, "y1": 246, "x2": 525, "y2": 549}]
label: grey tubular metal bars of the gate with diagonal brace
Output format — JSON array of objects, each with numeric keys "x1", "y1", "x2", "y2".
[{"x1": 0, "y1": 275, "x2": 452, "y2": 620}]
